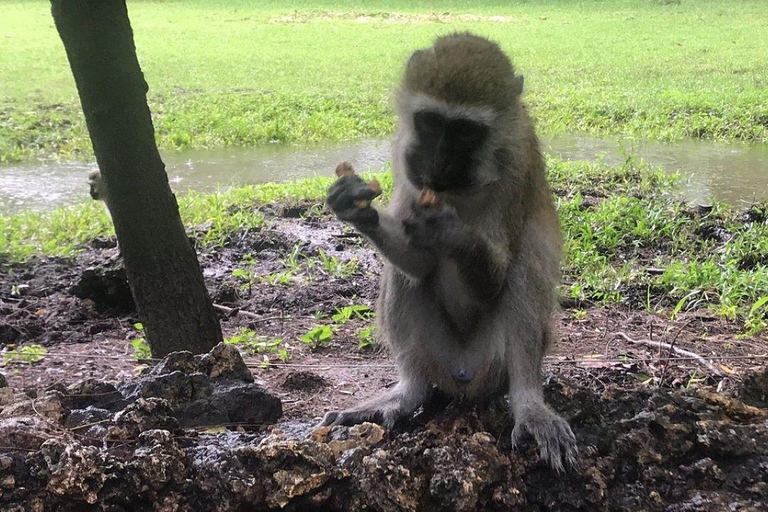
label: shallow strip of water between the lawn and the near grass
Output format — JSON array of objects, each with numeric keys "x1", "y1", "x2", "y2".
[{"x1": 0, "y1": 136, "x2": 768, "y2": 213}]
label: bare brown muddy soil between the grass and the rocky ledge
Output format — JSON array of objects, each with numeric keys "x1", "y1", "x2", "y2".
[{"x1": 0, "y1": 203, "x2": 768, "y2": 419}]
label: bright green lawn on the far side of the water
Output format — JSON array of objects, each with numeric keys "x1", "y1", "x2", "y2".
[{"x1": 0, "y1": 0, "x2": 768, "y2": 162}]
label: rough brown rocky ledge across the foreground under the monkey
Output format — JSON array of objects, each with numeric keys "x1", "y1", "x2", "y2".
[{"x1": 0, "y1": 345, "x2": 768, "y2": 512}]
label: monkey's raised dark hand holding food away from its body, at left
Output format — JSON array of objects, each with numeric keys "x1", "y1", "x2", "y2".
[{"x1": 325, "y1": 174, "x2": 380, "y2": 230}]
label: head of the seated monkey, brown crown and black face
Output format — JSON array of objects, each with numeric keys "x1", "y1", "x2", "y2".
[{"x1": 397, "y1": 33, "x2": 523, "y2": 192}]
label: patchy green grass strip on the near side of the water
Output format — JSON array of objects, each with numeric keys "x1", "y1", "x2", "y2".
[{"x1": 0, "y1": 158, "x2": 768, "y2": 330}]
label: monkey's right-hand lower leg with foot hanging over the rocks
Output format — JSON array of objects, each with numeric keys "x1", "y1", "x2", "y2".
[{"x1": 508, "y1": 319, "x2": 578, "y2": 472}]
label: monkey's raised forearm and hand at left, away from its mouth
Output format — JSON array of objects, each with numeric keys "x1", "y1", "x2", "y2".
[{"x1": 326, "y1": 175, "x2": 437, "y2": 280}]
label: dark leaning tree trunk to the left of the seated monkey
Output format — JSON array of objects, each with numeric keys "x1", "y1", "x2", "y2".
[{"x1": 51, "y1": 0, "x2": 222, "y2": 357}]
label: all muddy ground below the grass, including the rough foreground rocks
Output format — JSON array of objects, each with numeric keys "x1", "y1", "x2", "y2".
[{"x1": 0, "y1": 204, "x2": 768, "y2": 511}]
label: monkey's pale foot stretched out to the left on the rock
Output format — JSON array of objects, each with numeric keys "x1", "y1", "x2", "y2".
[{"x1": 320, "y1": 380, "x2": 429, "y2": 428}]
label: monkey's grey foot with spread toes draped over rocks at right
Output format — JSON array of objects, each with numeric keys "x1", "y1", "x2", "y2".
[{"x1": 512, "y1": 403, "x2": 579, "y2": 473}]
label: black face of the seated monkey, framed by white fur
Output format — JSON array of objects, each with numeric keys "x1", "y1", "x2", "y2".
[{"x1": 405, "y1": 110, "x2": 490, "y2": 192}]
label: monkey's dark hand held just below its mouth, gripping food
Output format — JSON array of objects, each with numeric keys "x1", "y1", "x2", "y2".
[{"x1": 403, "y1": 202, "x2": 466, "y2": 249}]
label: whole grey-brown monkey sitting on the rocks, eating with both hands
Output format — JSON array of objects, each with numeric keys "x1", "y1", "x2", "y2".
[{"x1": 320, "y1": 33, "x2": 578, "y2": 472}]
